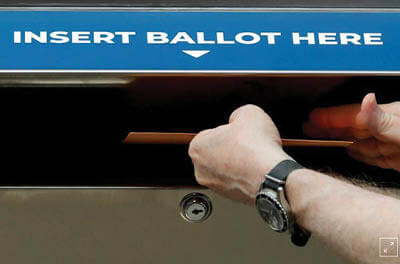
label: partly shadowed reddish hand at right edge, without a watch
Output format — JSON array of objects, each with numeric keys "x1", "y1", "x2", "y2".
[{"x1": 303, "y1": 94, "x2": 400, "y2": 171}]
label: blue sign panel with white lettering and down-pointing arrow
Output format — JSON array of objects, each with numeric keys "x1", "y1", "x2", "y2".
[{"x1": 0, "y1": 11, "x2": 400, "y2": 72}]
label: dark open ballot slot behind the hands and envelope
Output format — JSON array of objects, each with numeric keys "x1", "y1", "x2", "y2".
[{"x1": 0, "y1": 76, "x2": 399, "y2": 187}]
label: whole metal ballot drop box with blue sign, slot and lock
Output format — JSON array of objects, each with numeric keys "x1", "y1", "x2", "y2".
[{"x1": 0, "y1": 0, "x2": 400, "y2": 263}]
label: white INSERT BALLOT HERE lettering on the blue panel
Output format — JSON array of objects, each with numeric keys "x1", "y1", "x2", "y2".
[{"x1": 13, "y1": 31, "x2": 384, "y2": 46}]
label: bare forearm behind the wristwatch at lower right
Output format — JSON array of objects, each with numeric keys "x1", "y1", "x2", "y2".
[{"x1": 287, "y1": 169, "x2": 400, "y2": 263}]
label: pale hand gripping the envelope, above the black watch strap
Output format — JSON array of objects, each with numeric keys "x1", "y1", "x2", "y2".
[{"x1": 189, "y1": 105, "x2": 290, "y2": 204}]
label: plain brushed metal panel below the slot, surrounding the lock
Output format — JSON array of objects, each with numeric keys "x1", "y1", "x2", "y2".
[{"x1": 0, "y1": 189, "x2": 341, "y2": 264}]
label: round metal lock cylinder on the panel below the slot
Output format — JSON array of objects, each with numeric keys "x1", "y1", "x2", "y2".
[{"x1": 179, "y1": 193, "x2": 212, "y2": 223}]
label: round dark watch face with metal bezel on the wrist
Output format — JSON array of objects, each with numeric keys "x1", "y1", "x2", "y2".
[{"x1": 257, "y1": 195, "x2": 288, "y2": 232}]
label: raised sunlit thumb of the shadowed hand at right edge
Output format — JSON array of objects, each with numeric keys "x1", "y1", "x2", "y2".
[{"x1": 357, "y1": 93, "x2": 400, "y2": 144}]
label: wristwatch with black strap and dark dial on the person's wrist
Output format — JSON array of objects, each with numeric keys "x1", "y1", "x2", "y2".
[{"x1": 256, "y1": 160, "x2": 311, "y2": 247}]
